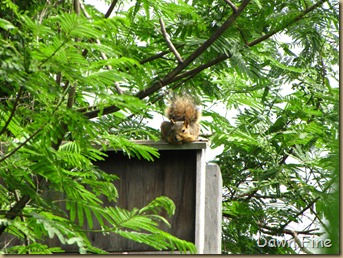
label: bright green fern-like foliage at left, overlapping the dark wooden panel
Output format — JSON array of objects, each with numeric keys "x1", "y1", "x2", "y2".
[{"x1": 0, "y1": 1, "x2": 196, "y2": 254}]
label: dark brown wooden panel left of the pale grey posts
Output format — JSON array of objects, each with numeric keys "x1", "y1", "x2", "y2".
[{"x1": 90, "y1": 150, "x2": 196, "y2": 251}]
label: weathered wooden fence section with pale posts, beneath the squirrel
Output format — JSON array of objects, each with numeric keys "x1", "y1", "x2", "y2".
[{"x1": 0, "y1": 141, "x2": 222, "y2": 254}]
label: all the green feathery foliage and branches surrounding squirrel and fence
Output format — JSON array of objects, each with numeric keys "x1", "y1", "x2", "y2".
[{"x1": 0, "y1": 0, "x2": 339, "y2": 254}]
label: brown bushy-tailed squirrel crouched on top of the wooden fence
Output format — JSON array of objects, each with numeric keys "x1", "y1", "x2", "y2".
[{"x1": 161, "y1": 95, "x2": 201, "y2": 144}]
